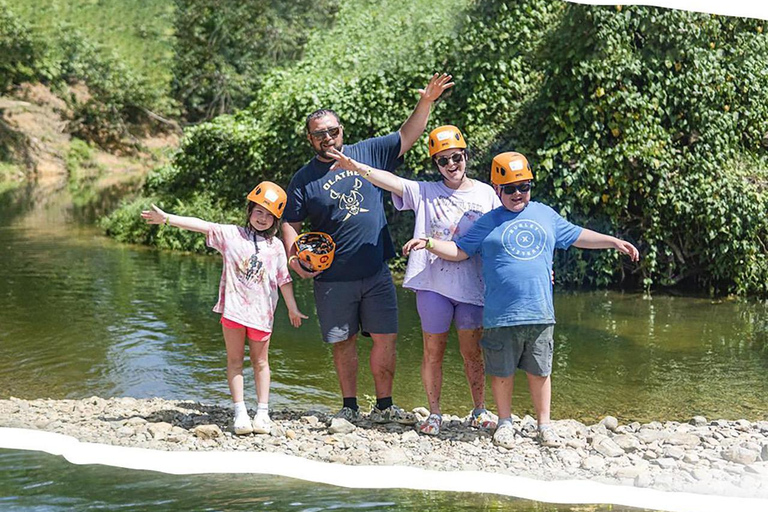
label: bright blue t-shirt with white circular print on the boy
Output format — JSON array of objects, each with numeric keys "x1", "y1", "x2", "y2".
[{"x1": 456, "y1": 201, "x2": 582, "y2": 328}]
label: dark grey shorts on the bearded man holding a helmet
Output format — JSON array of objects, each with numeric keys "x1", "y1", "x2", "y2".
[{"x1": 314, "y1": 263, "x2": 397, "y2": 343}]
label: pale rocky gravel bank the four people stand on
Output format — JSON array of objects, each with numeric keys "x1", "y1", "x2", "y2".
[{"x1": 0, "y1": 397, "x2": 768, "y2": 498}]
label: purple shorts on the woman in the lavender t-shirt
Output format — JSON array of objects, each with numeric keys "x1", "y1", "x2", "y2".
[{"x1": 416, "y1": 290, "x2": 483, "y2": 334}]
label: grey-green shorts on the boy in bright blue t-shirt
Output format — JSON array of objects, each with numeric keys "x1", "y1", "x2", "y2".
[{"x1": 480, "y1": 324, "x2": 555, "y2": 377}]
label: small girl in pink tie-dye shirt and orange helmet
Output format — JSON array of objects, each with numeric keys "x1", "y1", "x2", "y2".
[{"x1": 141, "y1": 181, "x2": 307, "y2": 434}]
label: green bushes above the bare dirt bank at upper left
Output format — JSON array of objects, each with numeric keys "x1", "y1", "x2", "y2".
[{"x1": 0, "y1": 3, "x2": 173, "y2": 149}]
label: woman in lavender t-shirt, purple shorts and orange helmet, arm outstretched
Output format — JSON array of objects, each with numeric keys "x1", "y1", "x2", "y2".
[{"x1": 329, "y1": 125, "x2": 501, "y2": 435}]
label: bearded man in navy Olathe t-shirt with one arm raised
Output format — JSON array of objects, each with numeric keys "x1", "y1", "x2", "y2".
[{"x1": 282, "y1": 73, "x2": 453, "y2": 424}]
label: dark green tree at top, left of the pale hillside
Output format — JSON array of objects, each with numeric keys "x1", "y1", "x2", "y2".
[{"x1": 173, "y1": 0, "x2": 338, "y2": 122}]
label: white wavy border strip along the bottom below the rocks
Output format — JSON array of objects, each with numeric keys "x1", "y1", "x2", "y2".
[{"x1": 0, "y1": 427, "x2": 768, "y2": 512}]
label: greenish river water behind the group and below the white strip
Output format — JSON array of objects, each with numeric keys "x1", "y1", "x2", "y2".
[{"x1": 0, "y1": 186, "x2": 768, "y2": 510}]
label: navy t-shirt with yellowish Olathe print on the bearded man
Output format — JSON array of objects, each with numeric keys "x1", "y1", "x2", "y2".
[{"x1": 283, "y1": 132, "x2": 403, "y2": 281}]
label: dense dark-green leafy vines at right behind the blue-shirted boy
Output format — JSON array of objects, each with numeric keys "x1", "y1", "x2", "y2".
[{"x1": 512, "y1": 6, "x2": 768, "y2": 294}]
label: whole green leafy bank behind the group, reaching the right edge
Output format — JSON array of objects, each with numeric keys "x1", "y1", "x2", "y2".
[{"x1": 106, "y1": 0, "x2": 768, "y2": 295}]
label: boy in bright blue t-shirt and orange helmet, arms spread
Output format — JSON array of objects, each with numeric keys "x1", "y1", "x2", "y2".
[{"x1": 403, "y1": 152, "x2": 639, "y2": 448}]
